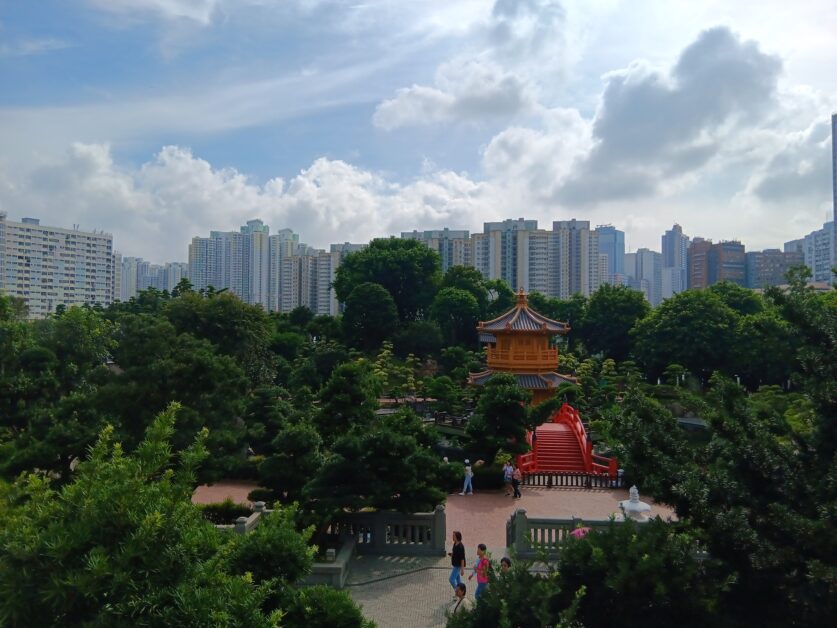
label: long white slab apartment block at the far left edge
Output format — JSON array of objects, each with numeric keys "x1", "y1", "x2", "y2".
[{"x1": 0, "y1": 212, "x2": 115, "y2": 318}]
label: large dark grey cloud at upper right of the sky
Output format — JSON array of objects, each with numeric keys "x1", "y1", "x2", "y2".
[{"x1": 556, "y1": 27, "x2": 782, "y2": 203}]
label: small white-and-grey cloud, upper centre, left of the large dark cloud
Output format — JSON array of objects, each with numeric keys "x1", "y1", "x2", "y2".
[{"x1": 372, "y1": 59, "x2": 535, "y2": 131}]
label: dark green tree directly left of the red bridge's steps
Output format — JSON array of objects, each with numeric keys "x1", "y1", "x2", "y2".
[{"x1": 467, "y1": 373, "x2": 532, "y2": 460}]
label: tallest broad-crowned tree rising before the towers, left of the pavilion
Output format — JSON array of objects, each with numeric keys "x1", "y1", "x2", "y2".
[{"x1": 334, "y1": 238, "x2": 441, "y2": 321}]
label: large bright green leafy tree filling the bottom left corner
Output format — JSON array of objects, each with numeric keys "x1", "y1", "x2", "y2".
[{"x1": 0, "y1": 406, "x2": 279, "y2": 626}]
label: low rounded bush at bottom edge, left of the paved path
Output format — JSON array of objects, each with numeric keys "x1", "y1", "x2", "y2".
[{"x1": 282, "y1": 585, "x2": 375, "y2": 628}]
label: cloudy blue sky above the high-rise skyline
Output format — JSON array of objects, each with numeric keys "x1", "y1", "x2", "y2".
[{"x1": 0, "y1": 0, "x2": 837, "y2": 262}]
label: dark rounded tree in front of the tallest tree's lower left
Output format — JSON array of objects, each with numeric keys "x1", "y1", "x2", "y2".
[{"x1": 343, "y1": 283, "x2": 398, "y2": 351}]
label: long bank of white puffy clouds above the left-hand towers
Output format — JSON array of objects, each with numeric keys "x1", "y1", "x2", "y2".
[{"x1": 0, "y1": 144, "x2": 500, "y2": 261}]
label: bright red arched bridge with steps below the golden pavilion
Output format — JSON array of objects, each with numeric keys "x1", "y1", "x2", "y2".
[{"x1": 517, "y1": 403, "x2": 618, "y2": 478}]
